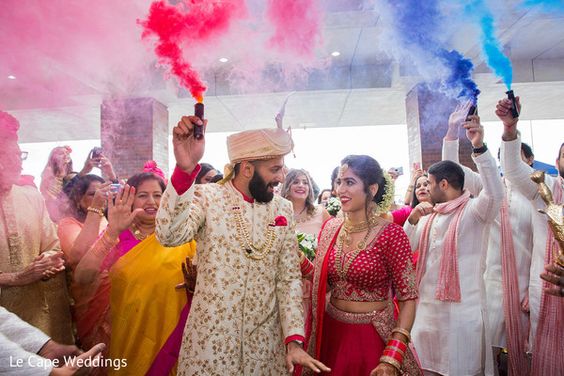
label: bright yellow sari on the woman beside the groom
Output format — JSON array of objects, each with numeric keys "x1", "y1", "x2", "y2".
[{"x1": 109, "y1": 234, "x2": 196, "y2": 375}]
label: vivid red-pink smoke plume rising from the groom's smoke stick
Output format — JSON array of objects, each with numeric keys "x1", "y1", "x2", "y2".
[{"x1": 139, "y1": 0, "x2": 247, "y2": 101}]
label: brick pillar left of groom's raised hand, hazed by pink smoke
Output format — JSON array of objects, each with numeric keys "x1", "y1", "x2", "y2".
[{"x1": 101, "y1": 98, "x2": 169, "y2": 178}]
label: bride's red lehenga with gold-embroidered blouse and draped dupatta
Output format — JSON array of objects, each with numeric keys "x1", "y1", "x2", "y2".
[{"x1": 302, "y1": 218, "x2": 422, "y2": 375}]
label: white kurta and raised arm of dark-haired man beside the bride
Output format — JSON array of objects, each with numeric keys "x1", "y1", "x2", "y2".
[{"x1": 404, "y1": 118, "x2": 503, "y2": 376}]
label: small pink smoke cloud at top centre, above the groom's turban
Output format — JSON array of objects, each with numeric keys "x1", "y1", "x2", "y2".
[{"x1": 266, "y1": 0, "x2": 321, "y2": 57}]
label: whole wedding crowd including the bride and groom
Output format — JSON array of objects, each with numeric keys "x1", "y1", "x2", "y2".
[{"x1": 0, "y1": 94, "x2": 564, "y2": 376}]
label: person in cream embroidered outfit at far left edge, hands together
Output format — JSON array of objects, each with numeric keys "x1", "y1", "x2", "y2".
[{"x1": 0, "y1": 112, "x2": 74, "y2": 344}]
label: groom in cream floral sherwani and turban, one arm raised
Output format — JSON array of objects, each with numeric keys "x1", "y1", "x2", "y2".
[{"x1": 156, "y1": 117, "x2": 328, "y2": 375}]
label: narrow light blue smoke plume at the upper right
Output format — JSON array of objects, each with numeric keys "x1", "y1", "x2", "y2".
[{"x1": 465, "y1": 0, "x2": 513, "y2": 90}]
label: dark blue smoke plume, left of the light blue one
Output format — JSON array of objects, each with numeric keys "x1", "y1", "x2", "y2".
[{"x1": 386, "y1": 0, "x2": 480, "y2": 103}]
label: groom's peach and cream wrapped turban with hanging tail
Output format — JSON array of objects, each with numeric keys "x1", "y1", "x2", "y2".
[{"x1": 223, "y1": 127, "x2": 294, "y2": 182}]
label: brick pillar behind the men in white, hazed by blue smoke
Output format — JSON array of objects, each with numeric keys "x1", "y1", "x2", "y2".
[{"x1": 405, "y1": 84, "x2": 476, "y2": 170}]
